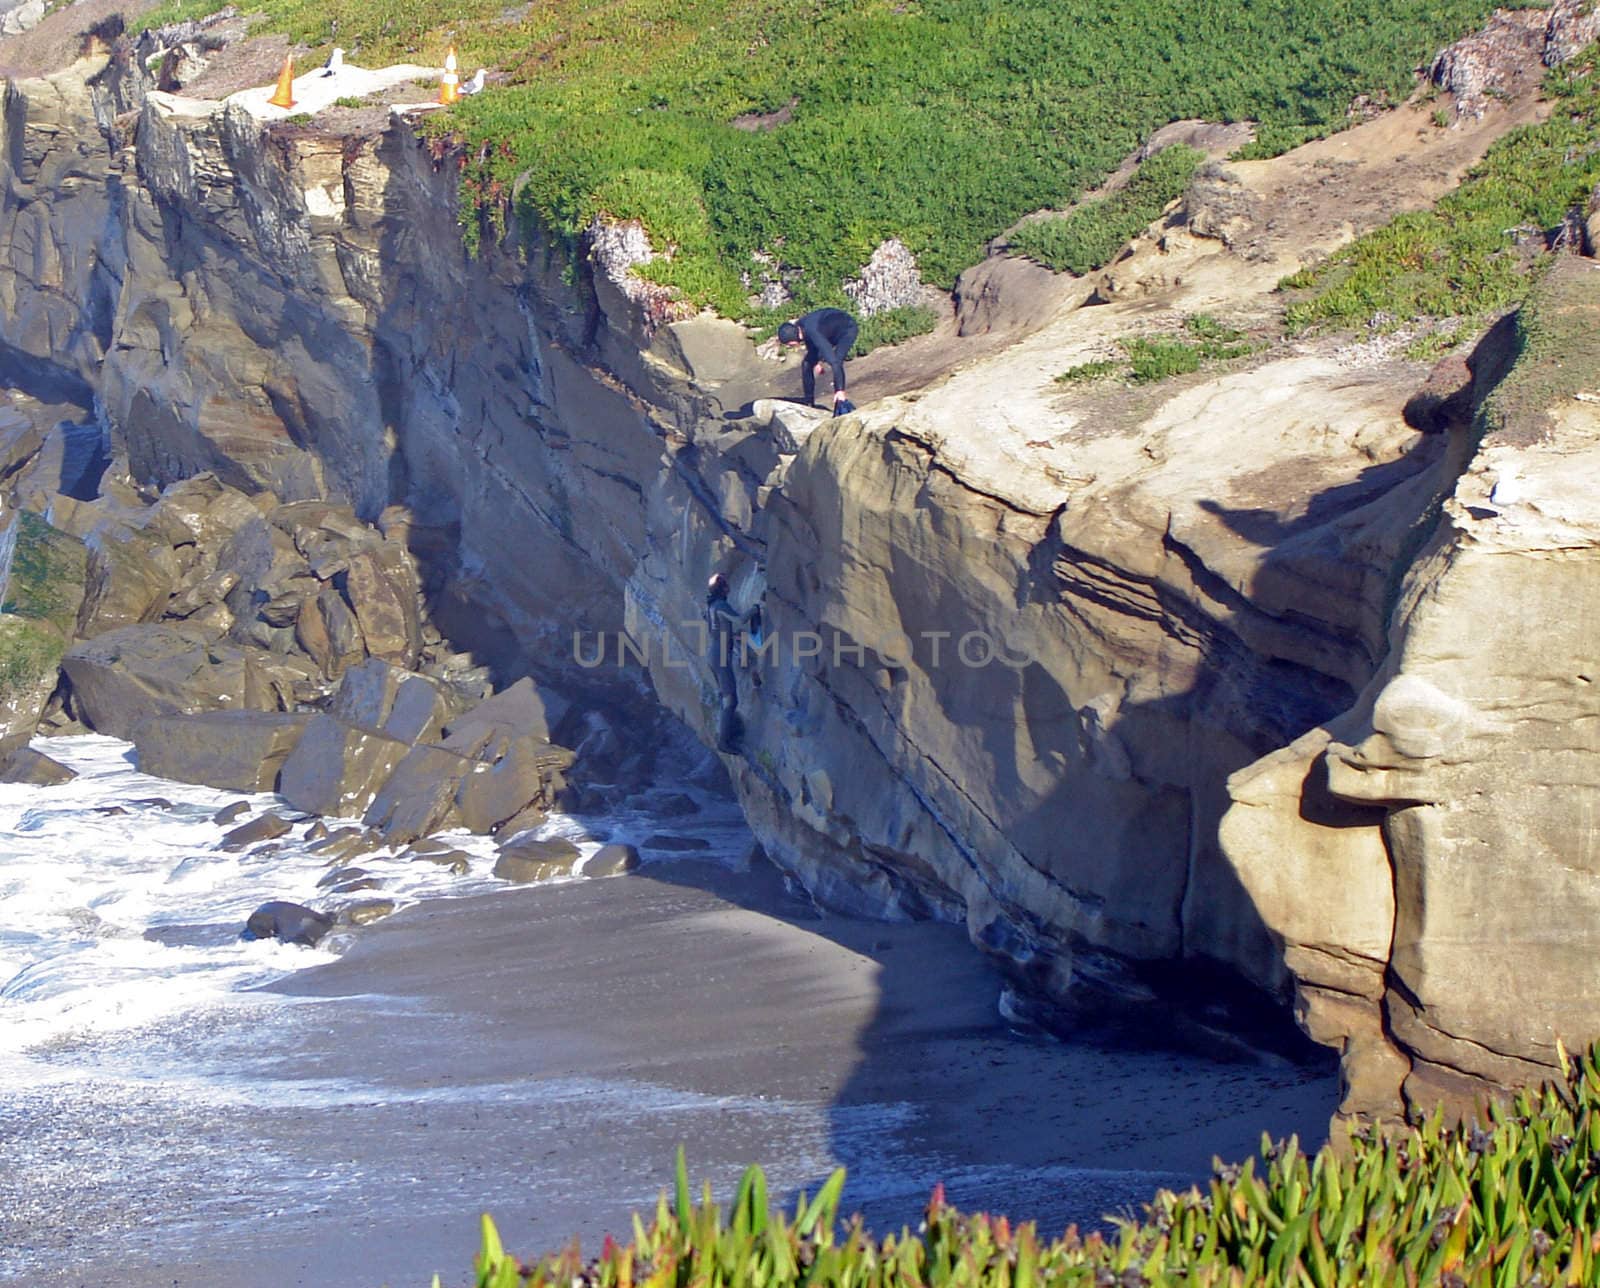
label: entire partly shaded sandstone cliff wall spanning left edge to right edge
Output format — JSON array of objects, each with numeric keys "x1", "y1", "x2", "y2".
[{"x1": 0, "y1": 50, "x2": 1594, "y2": 1110}]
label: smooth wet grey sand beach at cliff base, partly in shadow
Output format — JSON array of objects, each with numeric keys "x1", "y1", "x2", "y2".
[{"x1": 0, "y1": 862, "x2": 1336, "y2": 1288}]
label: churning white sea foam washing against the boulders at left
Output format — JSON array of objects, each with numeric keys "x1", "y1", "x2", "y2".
[{"x1": 0, "y1": 736, "x2": 749, "y2": 1074}]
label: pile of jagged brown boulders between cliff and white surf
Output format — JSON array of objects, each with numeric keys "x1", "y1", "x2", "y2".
[{"x1": 0, "y1": 448, "x2": 698, "y2": 946}]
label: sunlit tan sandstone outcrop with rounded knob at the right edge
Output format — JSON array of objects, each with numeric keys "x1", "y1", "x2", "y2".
[{"x1": 1222, "y1": 258, "x2": 1600, "y2": 1114}]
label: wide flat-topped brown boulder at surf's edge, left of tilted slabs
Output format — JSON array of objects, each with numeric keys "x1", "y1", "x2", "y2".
[{"x1": 131, "y1": 710, "x2": 310, "y2": 790}]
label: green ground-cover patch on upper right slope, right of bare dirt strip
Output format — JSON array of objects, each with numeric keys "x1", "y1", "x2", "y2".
[{"x1": 1282, "y1": 59, "x2": 1600, "y2": 333}]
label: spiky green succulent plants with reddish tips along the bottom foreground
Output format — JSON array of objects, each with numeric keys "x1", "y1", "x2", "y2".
[{"x1": 460, "y1": 1048, "x2": 1600, "y2": 1288}]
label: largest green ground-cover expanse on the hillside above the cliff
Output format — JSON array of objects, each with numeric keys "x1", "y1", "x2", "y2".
[{"x1": 128, "y1": 0, "x2": 1493, "y2": 309}]
